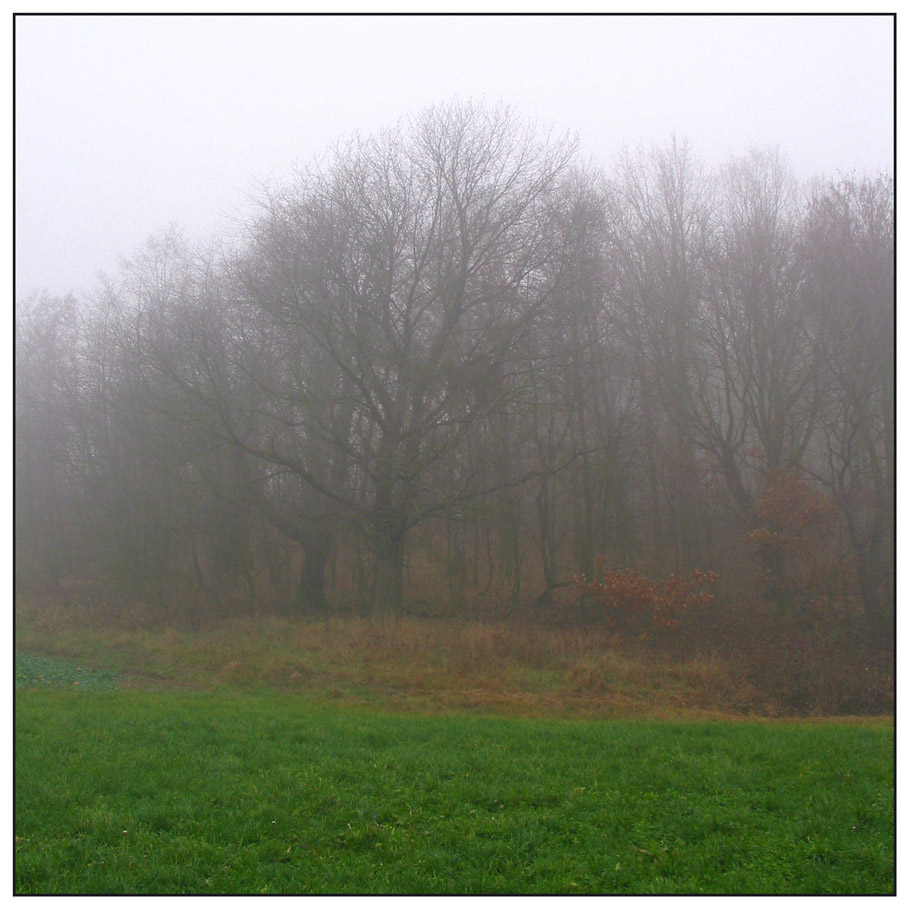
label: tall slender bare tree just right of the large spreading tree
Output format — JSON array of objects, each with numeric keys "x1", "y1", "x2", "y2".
[{"x1": 610, "y1": 140, "x2": 713, "y2": 568}]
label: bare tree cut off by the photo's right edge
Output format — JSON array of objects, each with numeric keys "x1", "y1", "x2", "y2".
[{"x1": 805, "y1": 176, "x2": 896, "y2": 633}]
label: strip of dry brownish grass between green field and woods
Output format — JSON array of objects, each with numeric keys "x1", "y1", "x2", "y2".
[{"x1": 16, "y1": 602, "x2": 892, "y2": 717}]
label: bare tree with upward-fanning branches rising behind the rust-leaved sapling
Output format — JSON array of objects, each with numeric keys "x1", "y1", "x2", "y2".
[{"x1": 691, "y1": 150, "x2": 821, "y2": 608}]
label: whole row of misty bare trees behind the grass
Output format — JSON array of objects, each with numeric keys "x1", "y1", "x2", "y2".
[{"x1": 15, "y1": 104, "x2": 895, "y2": 629}]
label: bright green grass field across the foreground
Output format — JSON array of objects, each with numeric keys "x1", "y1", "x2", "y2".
[{"x1": 15, "y1": 658, "x2": 894, "y2": 894}]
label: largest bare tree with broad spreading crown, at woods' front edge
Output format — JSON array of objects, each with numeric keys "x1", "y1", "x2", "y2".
[{"x1": 223, "y1": 105, "x2": 572, "y2": 610}]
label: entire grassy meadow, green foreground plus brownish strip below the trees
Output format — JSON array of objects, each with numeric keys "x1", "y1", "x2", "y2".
[{"x1": 15, "y1": 611, "x2": 895, "y2": 894}]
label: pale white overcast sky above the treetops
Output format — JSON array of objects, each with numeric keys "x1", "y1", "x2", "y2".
[{"x1": 15, "y1": 16, "x2": 894, "y2": 296}]
